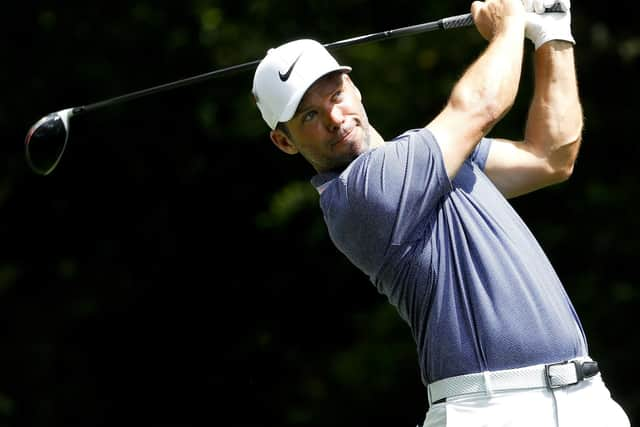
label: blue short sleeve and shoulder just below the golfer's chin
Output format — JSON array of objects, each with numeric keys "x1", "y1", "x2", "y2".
[{"x1": 320, "y1": 129, "x2": 452, "y2": 273}]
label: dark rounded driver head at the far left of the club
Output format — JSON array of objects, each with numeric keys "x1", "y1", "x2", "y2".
[{"x1": 25, "y1": 108, "x2": 73, "y2": 175}]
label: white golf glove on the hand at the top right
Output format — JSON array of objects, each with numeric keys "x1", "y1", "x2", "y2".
[{"x1": 522, "y1": 0, "x2": 576, "y2": 49}]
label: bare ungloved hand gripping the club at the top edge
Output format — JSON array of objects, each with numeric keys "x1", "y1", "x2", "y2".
[{"x1": 471, "y1": 0, "x2": 525, "y2": 40}]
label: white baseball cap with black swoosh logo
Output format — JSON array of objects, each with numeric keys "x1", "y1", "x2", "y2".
[{"x1": 253, "y1": 39, "x2": 351, "y2": 129}]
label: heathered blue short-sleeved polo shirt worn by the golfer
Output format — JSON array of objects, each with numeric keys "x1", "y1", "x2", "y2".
[{"x1": 312, "y1": 129, "x2": 587, "y2": 385}]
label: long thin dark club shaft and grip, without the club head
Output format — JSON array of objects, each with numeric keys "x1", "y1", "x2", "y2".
[{"x1": 72, "y1": 13, "x2": 473, "y2": 115}]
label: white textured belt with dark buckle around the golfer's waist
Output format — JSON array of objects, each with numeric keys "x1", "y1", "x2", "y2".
[{"x1": 427, "y1": 358, "x2": 600, "y2": 405}]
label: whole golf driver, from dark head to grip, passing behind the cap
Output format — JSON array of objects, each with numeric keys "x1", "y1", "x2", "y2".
[{"x1": 25, "y1": 3, "x2": 563, "y2": 175}]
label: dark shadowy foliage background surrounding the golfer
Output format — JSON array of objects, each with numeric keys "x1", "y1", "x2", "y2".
[{"x1": 0, "y1": 0, "x2": 640, "y2": 427}]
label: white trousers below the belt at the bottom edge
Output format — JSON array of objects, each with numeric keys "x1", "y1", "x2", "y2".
[{"x1": 423, "y1": 374, "x2": 630, "y2": 427}]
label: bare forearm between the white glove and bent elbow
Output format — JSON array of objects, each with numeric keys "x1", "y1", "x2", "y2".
[{"x1": 525, "y1": 41, "x2": 583, "y2": 157}]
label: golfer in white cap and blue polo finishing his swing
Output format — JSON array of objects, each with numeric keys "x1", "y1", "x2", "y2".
[{"x1": 253, "y1": 0, "x2": 629, "y2": 427}]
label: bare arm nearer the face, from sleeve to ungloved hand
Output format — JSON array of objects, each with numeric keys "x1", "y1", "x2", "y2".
[{"x1": 427, "y1": 6, "x2": 524, "y2": 177}]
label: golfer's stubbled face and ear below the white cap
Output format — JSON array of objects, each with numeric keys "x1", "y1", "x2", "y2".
[{"x1": 271, "y1": 73, "x2": 371, "y2": 173}]
